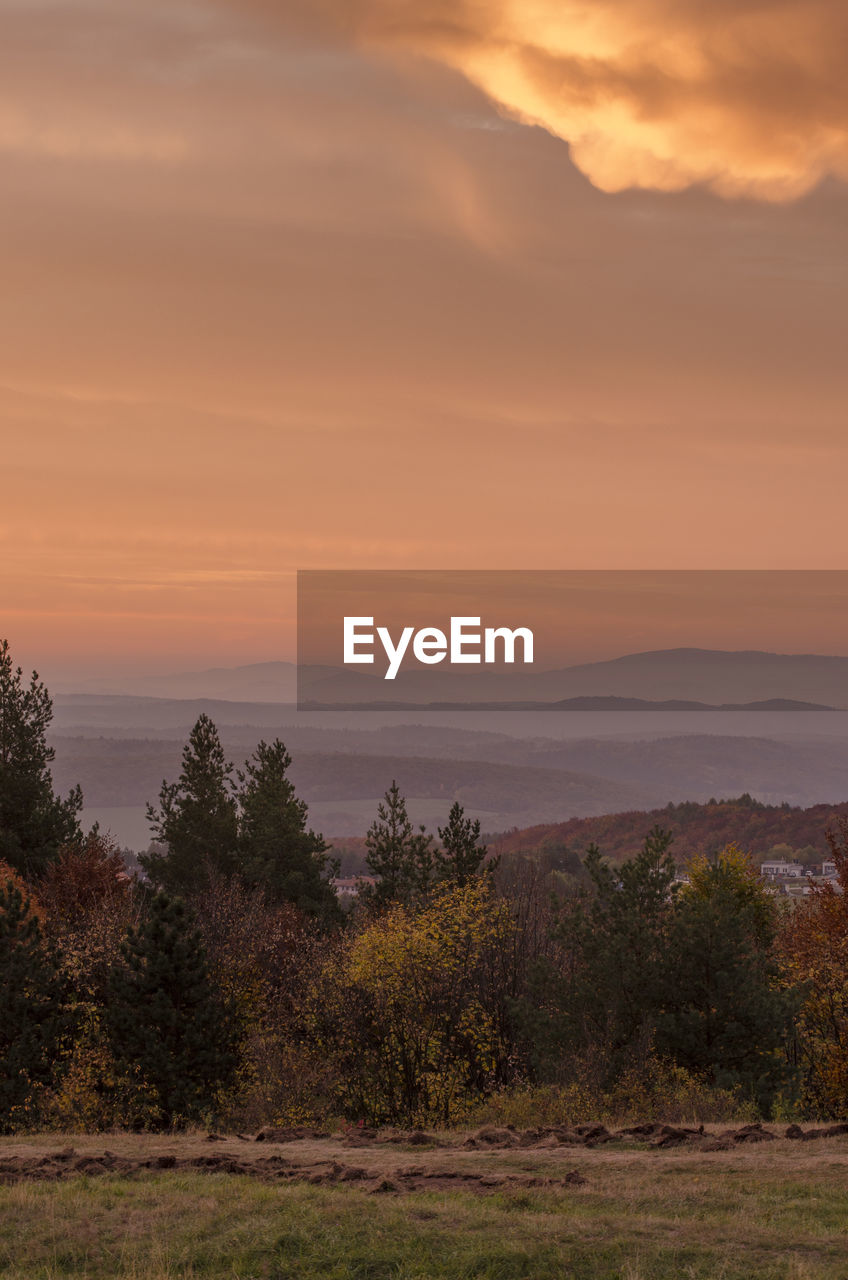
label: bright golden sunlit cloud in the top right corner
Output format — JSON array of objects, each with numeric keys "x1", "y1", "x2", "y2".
[{"x1": 234, "y1": 0, "x2": 848, "y2": 201}]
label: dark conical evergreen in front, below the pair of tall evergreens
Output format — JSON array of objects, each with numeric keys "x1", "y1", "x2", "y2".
[{"x1": 106, "y1": 893, "x2": 236, "y2": 1128}]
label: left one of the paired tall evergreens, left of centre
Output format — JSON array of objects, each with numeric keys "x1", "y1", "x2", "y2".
[{"x1": 140, "y1": 714, "x2": 238, "y2": 893}]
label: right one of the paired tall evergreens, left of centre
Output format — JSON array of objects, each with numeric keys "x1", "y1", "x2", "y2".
[{"x1": 238, "y1": 739, "x2": 338, "y2": 916}]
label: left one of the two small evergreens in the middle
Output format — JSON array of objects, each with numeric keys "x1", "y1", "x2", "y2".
[{"x1": 365, "y1": 781, "x2": 433, "y2": 906}]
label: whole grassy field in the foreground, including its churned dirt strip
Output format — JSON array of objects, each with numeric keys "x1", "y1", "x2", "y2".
[{"x1": 0, "y1": 1135, "x2": 848, "y2": 1280}]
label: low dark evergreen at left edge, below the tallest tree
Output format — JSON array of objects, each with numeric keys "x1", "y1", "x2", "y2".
[{"x1": 0, "y1": 879, "x2": 61, "y2": 1132}]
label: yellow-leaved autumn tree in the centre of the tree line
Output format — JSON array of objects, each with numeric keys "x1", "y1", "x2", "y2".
[{"x1": 305, "y1": 879, "x2": 512, "y2": 1125}]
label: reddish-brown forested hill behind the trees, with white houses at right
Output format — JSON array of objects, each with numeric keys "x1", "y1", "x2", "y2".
[{"x1": 492, "y1": 796, "x2": 848, "y2": 863}]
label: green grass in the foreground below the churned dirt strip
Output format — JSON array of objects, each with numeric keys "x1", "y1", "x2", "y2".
[{"x1": 0, "y1": 1157, "x2": 848, "y2": 1280}]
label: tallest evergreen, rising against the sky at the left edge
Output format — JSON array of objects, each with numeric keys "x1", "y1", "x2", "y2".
[{"x1": 0, "y1": 640, "x2": 82, "y2": 877}]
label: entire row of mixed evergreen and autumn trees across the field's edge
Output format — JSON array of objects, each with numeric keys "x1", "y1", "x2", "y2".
[{"x1": 0, "y1": 641, "x2": 848, "y2": 1130}]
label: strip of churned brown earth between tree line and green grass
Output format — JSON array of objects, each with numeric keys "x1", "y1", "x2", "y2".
[{"x1": 6, "y1": 1123, "x2": 848, "y2": 1193}]
